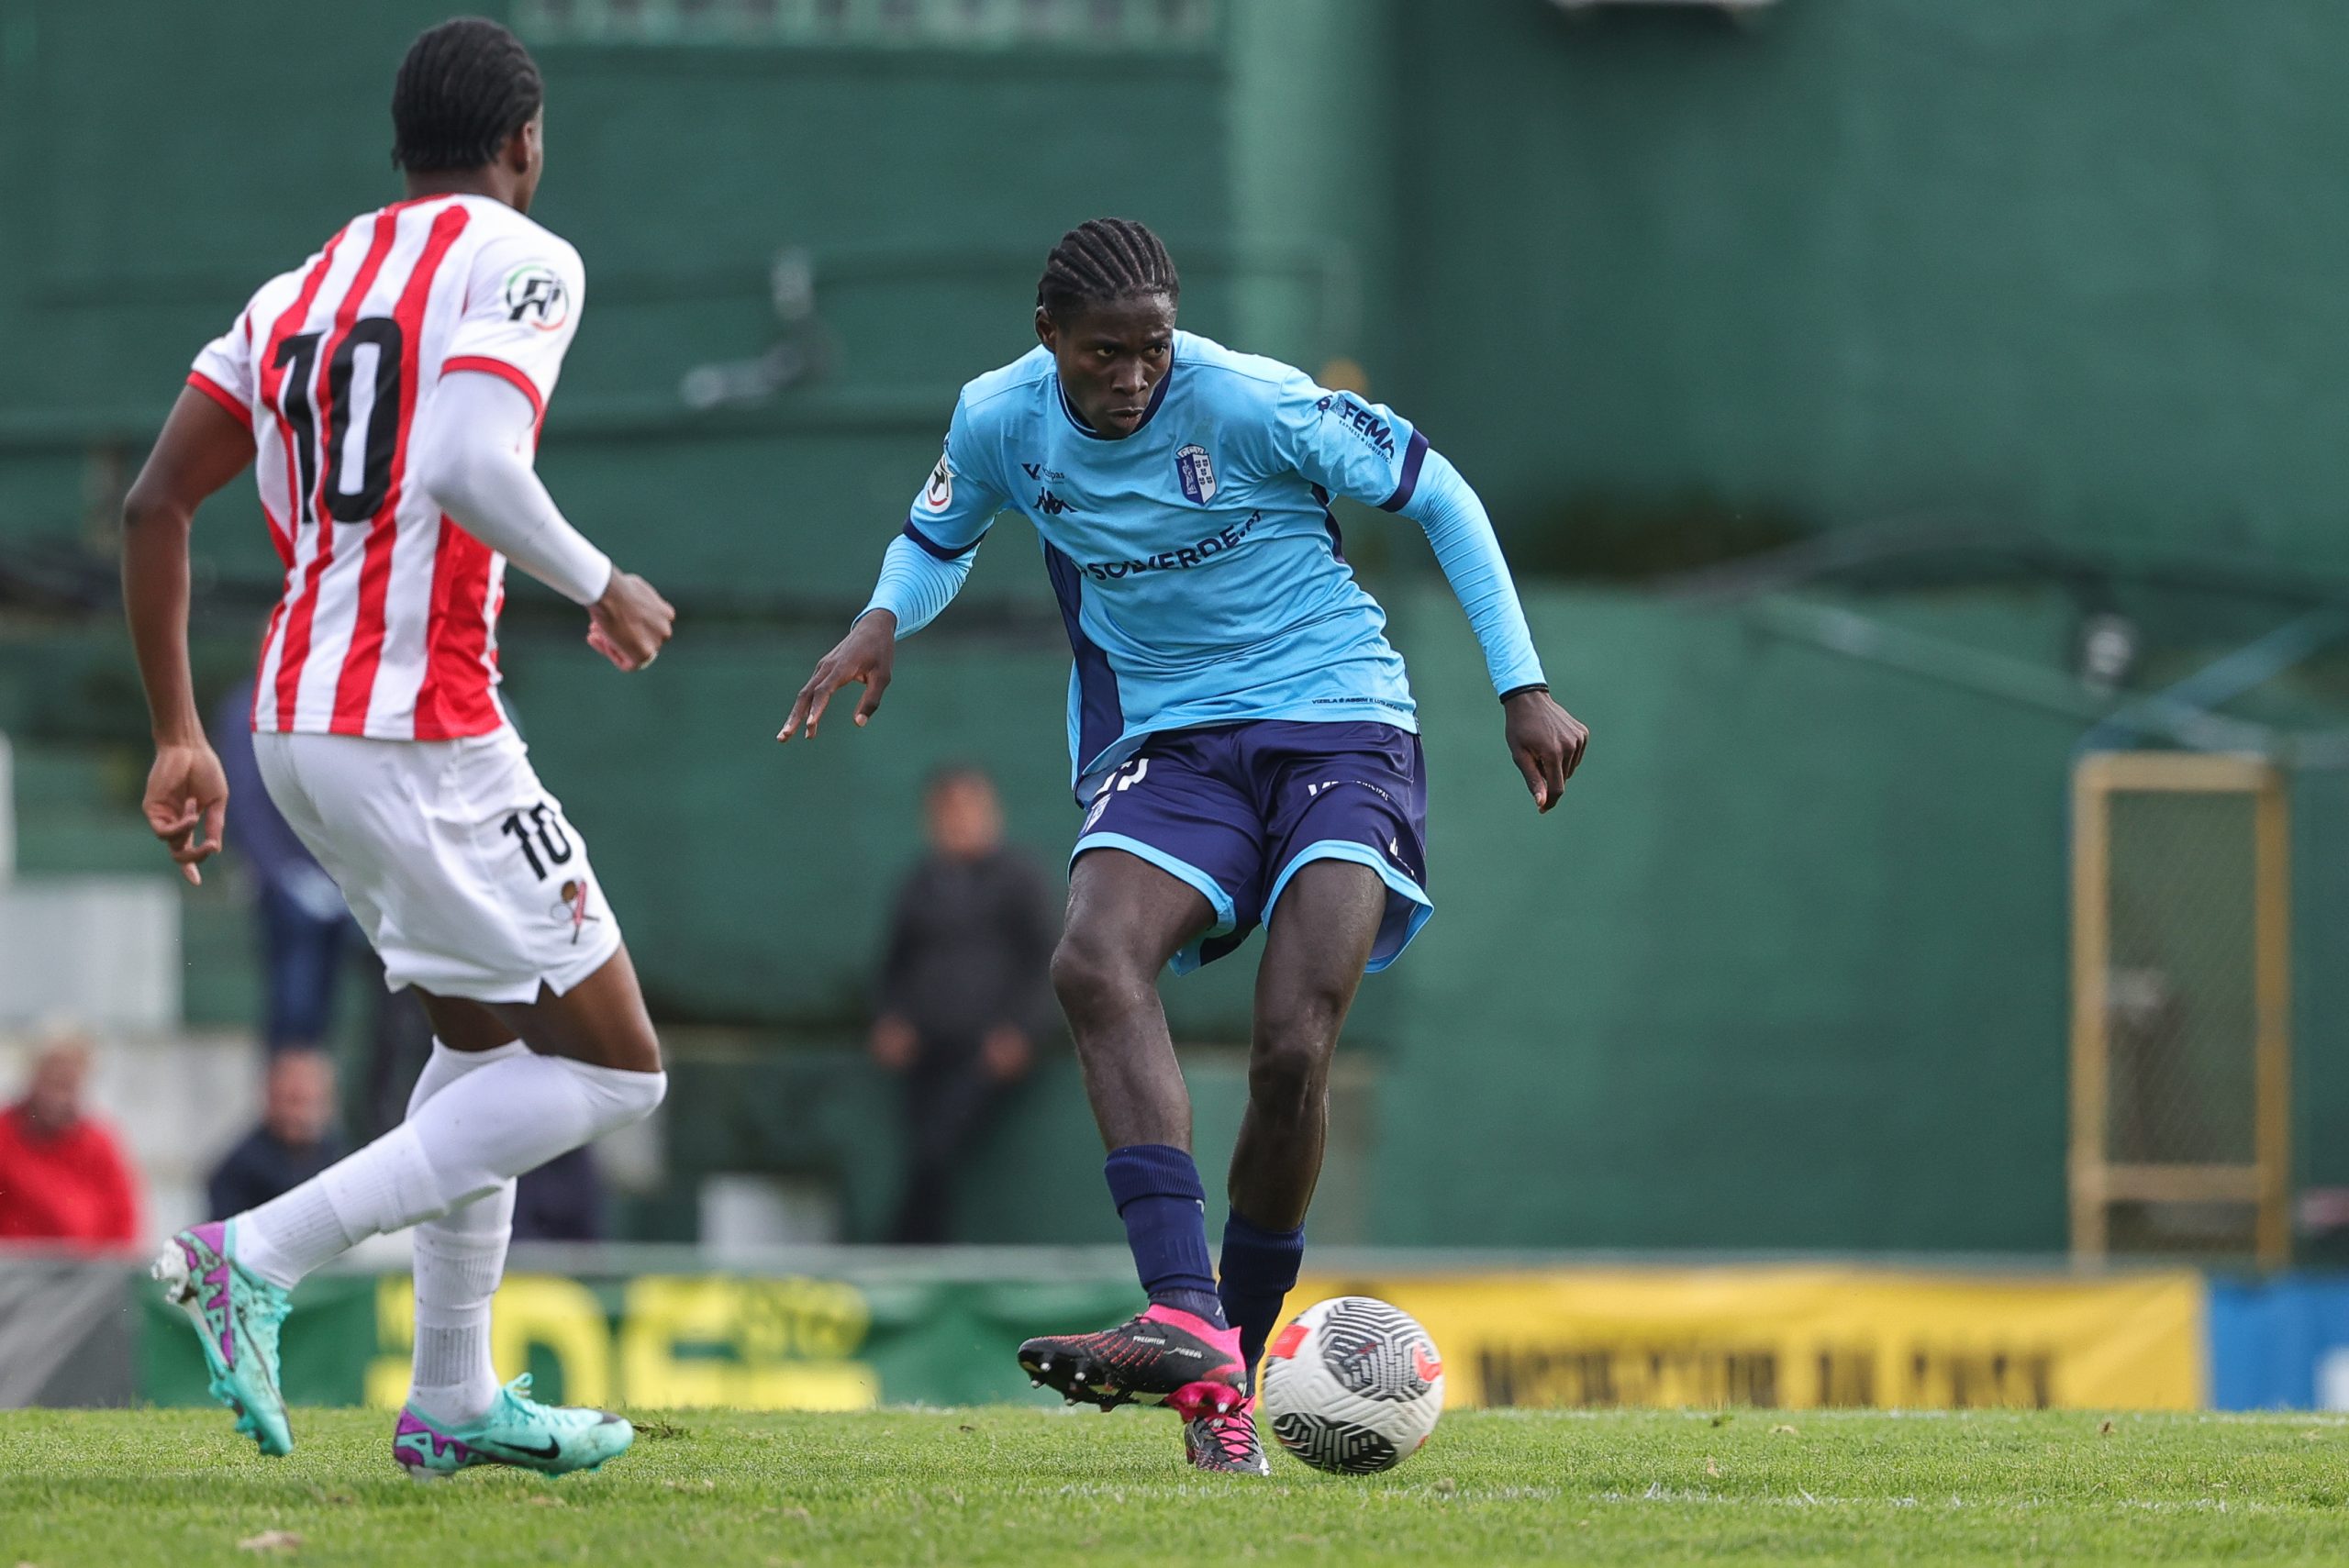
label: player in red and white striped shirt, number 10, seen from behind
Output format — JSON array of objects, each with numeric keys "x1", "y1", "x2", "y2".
[{"x1": 122, "y1": 18, "x2": 672, "y2": 1474}]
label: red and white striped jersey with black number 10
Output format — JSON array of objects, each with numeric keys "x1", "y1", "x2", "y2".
[{"x1": 188, "y1": 195, "x2": 587, "y2": 740}]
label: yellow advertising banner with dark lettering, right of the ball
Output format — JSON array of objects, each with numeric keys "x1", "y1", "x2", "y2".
[{"x1": 1289, "y1": 1265, "x2": 2208, "y2": 1411}]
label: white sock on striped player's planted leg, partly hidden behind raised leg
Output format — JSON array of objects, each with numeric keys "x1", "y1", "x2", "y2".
[{"x1": 408, "y1": 1040, "x2": 529, "y2": 1427}]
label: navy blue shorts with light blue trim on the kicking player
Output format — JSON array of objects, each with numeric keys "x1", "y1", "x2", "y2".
[{"x1": 1069, "y1": 718, "x2": 1435, "y2": 974}]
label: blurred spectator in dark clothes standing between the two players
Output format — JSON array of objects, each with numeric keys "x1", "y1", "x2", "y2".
[{"x1": 872, "y1": 768, "x2": 1060, "y2": 1241}]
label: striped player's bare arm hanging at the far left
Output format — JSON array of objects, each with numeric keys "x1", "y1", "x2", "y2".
[{"x1": 122, "y1": 387, "x2": 253, "y2": 883}]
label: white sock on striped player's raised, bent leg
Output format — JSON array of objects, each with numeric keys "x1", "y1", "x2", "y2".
[{"x1": 238, "y1": 1051, "x2": 670, "y2": 1289}]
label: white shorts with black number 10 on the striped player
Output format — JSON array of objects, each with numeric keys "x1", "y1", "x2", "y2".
[{"x1": 253, "y1": 730, "x2": 620, "y2": 1002}]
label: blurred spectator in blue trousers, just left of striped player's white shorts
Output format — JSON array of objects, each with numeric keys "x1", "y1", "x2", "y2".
[{"x1": 211, "y1": 681, "x2": 366, "y2": 1054}]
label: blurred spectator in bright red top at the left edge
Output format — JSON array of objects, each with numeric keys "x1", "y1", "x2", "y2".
[{"x1": 0, "y1": 1035, "x2": 139, "y2": 1244}]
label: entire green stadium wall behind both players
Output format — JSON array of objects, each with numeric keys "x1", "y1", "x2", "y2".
[{"x1": 0, "y1": 0, "x2": 2349, "y2": 1251}]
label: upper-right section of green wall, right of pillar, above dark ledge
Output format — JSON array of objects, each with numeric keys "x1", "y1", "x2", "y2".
[{"x1": 1396, "y1": 0, "x2": 2349, "y2": 571}]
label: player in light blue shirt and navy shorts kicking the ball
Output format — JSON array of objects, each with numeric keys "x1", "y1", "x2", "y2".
[{"x1": 777, "y1": 218, "x2": 1588, "y2": 1474}]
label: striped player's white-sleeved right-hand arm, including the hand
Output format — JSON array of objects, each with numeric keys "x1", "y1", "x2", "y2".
[{"x1": 411, "y1": 371, "x2": 676, "y2": 669}]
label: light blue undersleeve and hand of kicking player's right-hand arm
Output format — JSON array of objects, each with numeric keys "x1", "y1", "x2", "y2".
[{"x1": 1400, "y1": 440, "x2": 1590, "y2": 812}]
